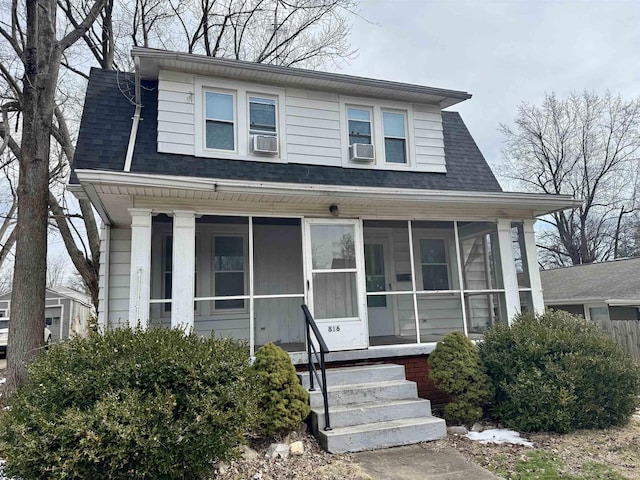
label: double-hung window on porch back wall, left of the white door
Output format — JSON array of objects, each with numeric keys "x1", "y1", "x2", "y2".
[{"x1": 213, "y1": 236, "x2": 245, "y2": 310}]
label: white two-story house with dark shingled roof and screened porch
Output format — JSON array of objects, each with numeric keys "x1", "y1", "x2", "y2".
[{"x1": 71, "y1": 48, "x2": 577, "y2": 450}]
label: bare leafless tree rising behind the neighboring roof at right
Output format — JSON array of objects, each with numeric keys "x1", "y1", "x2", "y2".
[{"x1": 501, "y1": 92, "x2": 640, "y2": 265}]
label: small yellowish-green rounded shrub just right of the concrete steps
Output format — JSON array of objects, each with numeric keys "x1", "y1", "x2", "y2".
[{"x1": 429, "y1": 332, "x2": 493, "y2": 424}]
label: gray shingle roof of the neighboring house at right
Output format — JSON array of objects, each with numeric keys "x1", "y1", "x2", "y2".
[{"x1": 540, "y1": 257, "x2": 640, "y2": 305}]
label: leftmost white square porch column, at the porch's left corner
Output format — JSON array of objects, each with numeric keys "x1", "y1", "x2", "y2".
[{"x1": 129, "y1": 208, "x2": 151, "y2": 329}]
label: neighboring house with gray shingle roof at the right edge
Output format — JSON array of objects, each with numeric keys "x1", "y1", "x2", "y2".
[{"x1": 540, "y1": 257, "x2": 640, "y2": 321}]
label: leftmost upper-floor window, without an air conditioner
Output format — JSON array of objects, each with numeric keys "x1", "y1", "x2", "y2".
[{"x1": 205, "y1": 92, "x2": 236, "y2": 151}]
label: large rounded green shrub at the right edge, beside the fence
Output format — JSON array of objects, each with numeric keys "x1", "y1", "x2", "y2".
[{"x1": 479, "y1": 310, "x2": 640, "y2": 432}]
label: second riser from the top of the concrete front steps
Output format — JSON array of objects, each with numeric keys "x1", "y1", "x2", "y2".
[{"x1": 309, "y1": 382, "x2": 418, "y2": 411}]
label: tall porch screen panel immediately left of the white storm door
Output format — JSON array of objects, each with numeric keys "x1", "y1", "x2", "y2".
[{"x1": 253, "y1": 217, "x2": 305, "y2": 352}]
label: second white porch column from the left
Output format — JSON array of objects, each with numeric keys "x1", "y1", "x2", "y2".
[{"x1": 171, "y1": 210, "x2": 196, "y2": 330}]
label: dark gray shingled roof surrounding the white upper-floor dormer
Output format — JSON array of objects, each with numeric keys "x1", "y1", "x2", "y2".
[{"x1": 71, "y1": 69, "x2": 502, "y2": 192}]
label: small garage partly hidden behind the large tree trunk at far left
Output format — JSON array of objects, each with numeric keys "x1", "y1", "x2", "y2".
[{"x1": 0, "y1": 287, "x2": 94, "y2": 356}]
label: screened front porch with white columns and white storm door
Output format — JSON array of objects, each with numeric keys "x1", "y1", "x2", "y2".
[{"x1": 130, "y1": 209, "x2": 543, "y2": 353}]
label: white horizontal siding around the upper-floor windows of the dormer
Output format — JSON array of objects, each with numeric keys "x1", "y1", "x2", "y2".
[{"x1": 157, "y1": 71, "x2": 446, "y2": 173}]
